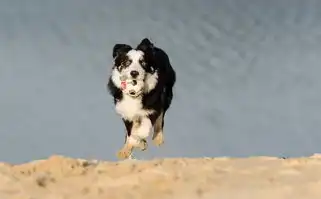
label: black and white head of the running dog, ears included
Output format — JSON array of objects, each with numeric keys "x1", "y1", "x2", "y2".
[{"x1": 112, "y1": 39, "x2": 154, "y2": 97}]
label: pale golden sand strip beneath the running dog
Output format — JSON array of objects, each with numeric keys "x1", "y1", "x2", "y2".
[{"x1": 0, "y1": 154, "x2": 321, "y2": 199}]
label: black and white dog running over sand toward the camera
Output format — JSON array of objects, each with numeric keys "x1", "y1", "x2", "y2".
[{"x1": 107, "y1": 38, "x2": 176, "y2": 159}]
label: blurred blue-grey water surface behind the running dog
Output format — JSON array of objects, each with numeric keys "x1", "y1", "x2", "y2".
[{"x1": 0, "y1": 0, "x2": 321, "y2": 163}]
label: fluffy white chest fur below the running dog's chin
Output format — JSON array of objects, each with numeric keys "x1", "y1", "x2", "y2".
[{"x1": 116, "y1": 95, "x2": 153, "y2": 121}]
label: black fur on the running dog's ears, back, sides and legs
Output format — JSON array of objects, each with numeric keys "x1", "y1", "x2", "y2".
[{"x1": 107, "y1": 38, "x2": 176, "y2": 141}]
